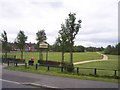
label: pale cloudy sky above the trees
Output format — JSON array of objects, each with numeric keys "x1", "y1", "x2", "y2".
[{"x1": 0, "y1": 0, "x2": 119, "y2": 47}]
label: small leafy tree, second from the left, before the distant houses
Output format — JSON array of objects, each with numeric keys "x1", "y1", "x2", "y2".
[{"x1": 15, "y1": 30, "x2": 27, "y2": 60}]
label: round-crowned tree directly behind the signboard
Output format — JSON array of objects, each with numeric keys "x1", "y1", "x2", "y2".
[{"x1": 36, "y1": 30, "x2": 47, "y2": 59}]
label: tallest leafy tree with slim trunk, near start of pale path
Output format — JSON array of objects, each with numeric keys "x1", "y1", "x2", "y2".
[{"x1": 64, "y1": 13, "x2": 82, "y2": 65}]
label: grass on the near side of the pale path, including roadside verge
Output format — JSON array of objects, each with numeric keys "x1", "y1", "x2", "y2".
[{"x1": 6, "y1": 52, "x2": 118, "y2": 82}]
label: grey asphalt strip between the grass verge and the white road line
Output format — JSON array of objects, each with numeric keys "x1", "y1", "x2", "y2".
[{"x1": 2, "y1": 69, "x2": 118, "y2": 88}]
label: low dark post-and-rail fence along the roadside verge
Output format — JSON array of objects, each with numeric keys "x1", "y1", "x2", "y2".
[{"x1": 4, "y1": 61, "x2": 120, "y2": 77}]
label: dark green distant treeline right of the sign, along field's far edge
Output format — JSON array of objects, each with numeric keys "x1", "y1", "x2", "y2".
[{"x1": 49, "y1": 43, "x2": 120, "y2": 55}]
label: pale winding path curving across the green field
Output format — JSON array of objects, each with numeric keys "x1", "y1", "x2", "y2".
[{"x1": 74, "y1": 52, "x2": 108, "y2": 65}]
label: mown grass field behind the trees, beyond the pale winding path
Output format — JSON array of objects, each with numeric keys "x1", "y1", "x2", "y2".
[{"x1": 8, "y1": 52, "x2": 102, "y2": 62}]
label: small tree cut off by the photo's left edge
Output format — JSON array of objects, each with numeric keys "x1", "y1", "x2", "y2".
[{"x1": 1, "y1": 31, "x2": 8, "y2": 57}]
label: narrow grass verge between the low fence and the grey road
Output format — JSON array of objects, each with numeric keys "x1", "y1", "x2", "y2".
[{"x1": 6, "y1": 66, "x2": 118, "y2": 83}]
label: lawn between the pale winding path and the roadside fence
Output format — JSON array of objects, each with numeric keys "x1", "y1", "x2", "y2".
[{"x1": 75, "y1": 55, "x2": 119, "y2": 76}]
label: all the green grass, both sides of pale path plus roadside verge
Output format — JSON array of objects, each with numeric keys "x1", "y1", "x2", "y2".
[{"x1": 3, "y1": 52, "x2": 118, "y2": 82}]
